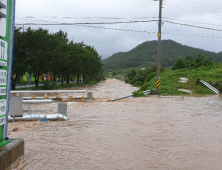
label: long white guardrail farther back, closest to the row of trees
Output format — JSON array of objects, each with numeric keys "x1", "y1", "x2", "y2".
[{"x1": 11, "y1": 90, "x2": 87, "y2": 99}]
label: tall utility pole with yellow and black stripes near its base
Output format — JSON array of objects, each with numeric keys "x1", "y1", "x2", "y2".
[{"x1": 156, "y1": 0, "x2": 163, "y2": 95}]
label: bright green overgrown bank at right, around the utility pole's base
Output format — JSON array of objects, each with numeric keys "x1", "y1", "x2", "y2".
[{"x1": 140, "y1": 64, "x2": 222, "y2": 95}]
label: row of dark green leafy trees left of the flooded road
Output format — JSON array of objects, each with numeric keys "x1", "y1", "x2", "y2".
[{"x1": 12, "y1": 28, "x2": 103, "y2": 89}]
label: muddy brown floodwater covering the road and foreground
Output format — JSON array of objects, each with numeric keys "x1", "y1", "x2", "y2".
[{"x1": 6, "y1": 79, "x2": 222, "y2": 170}]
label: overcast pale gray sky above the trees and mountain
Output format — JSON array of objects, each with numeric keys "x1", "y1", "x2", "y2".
[{"x1": 15, "y1": 0, "x2": 222, "y2": 58}]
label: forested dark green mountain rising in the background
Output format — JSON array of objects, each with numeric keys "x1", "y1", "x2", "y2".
[{"x1": 102, "y1": 40, "x2": 222, "y2": 71}]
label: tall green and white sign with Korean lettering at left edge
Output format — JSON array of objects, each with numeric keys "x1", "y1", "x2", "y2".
[{"x1": 0, "y1": 0, "x2": 15, "y2": 147}]
